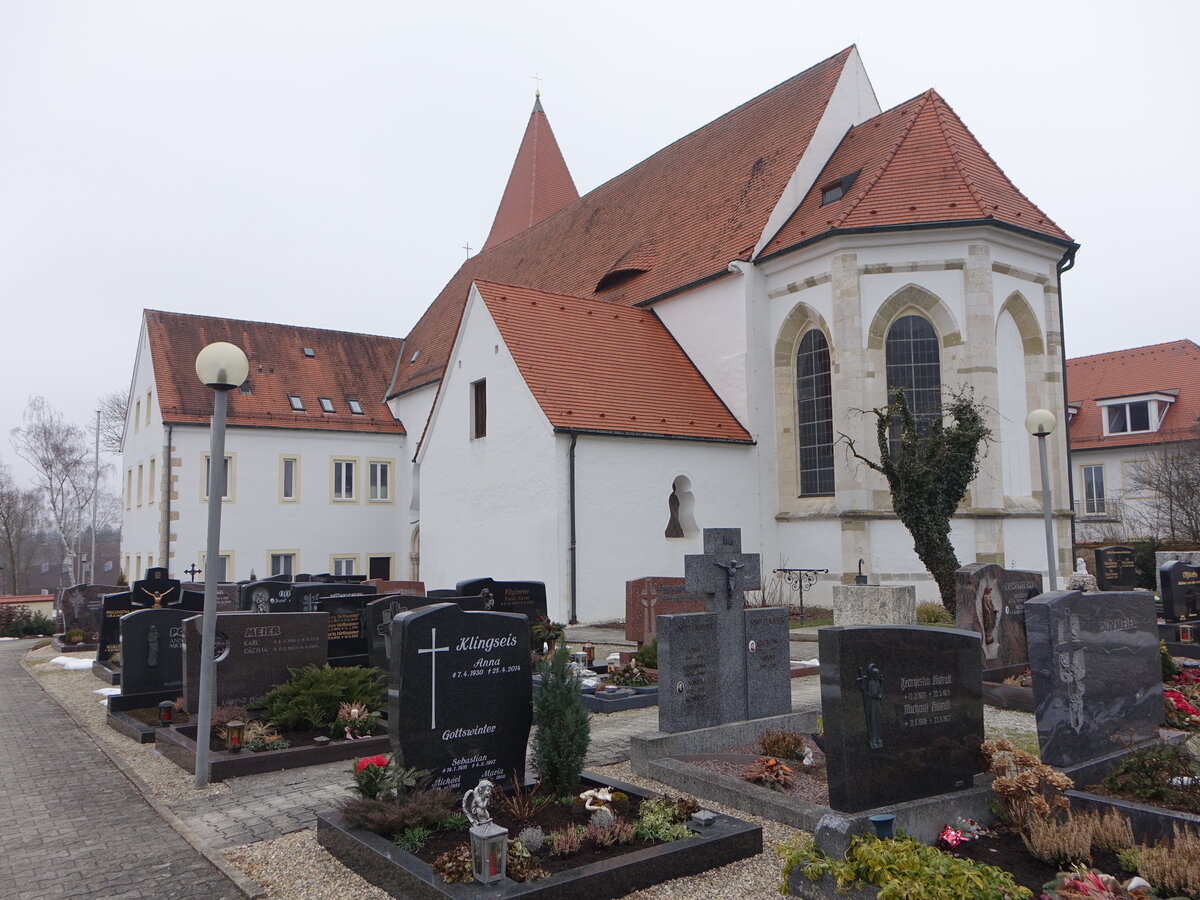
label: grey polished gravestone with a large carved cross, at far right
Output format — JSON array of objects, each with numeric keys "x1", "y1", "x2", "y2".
[{"x1": 1025, "y1": 590, "x2": 1163, "y2": 768}]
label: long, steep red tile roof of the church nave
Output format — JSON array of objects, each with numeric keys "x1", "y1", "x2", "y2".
[{"x1": 389, "y1": 48, "x2": 851, "y2": 395}]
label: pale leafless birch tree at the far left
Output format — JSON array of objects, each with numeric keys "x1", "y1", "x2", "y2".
[{"x1": 12, "y1": 396, "x2": 96, "y2": 580}]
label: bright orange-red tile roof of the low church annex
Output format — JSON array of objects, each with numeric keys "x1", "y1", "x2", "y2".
[{"x1": 475, "y1": 281, "x2": 751, "y2": 442}]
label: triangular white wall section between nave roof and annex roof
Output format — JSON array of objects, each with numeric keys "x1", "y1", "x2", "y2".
[{"x1": 654, "y1": 275, "x2": 748, "y2": 425}]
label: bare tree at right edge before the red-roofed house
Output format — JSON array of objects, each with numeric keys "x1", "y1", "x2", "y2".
[{"x1": 1124, "y1": 431, "x2": 1200, "y2": 541}]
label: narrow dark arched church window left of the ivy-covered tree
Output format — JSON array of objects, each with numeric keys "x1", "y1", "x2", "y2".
[{"x1": 796, "y1": 329, "x2": 833, "y2": 497}]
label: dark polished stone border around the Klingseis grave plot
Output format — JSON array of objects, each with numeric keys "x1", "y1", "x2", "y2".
[{"x1": 317, "y1": 772, "x2": 762, "y2": 900}]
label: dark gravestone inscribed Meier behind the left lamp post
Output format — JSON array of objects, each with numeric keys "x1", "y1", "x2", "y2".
[{"x1": 184, "y1": 612, "x2": 329, "y2": 713}]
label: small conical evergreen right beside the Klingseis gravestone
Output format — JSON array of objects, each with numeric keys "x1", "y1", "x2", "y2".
[{"x1": 533, "y1": 647, "x2": 590, "y2": 797}]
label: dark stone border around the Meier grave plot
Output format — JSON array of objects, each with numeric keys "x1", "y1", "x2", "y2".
[{"x1": 155, "y1": 725, "x2": 391, "y2": 781}]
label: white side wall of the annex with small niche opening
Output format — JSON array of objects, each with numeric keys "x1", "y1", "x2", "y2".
[{"x1": 558, "y1": 434, "x2": 753, "y2": 622}]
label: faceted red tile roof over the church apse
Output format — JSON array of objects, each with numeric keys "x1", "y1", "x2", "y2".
[{"x1": 762, "y1": 90, "x2": 1070, "y2": 256}]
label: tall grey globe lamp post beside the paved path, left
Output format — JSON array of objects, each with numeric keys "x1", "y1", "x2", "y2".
[{"x1": 196, "y1": 341, "x2": 250, "y2": 787}]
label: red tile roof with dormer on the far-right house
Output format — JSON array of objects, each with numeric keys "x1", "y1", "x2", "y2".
[{"x1": 1067, "y1": 341, "x2": 1200, "y2": 450}]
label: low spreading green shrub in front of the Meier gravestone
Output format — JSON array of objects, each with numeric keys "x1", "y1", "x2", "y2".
[{"x1": 253, "y1": 664, "x2": 386, "y2": 737}]
